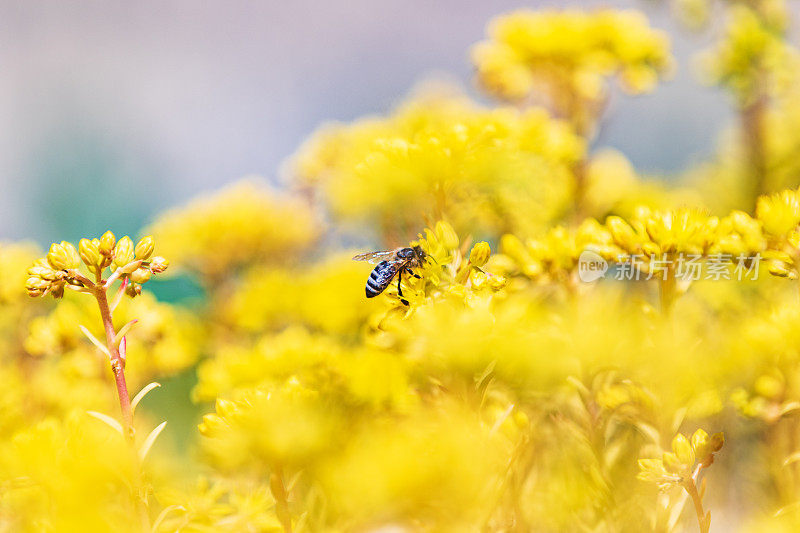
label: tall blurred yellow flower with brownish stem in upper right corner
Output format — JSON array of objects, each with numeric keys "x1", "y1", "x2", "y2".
[{"x1": 686, "y1": 0, "x2": 800, "y2": 215}]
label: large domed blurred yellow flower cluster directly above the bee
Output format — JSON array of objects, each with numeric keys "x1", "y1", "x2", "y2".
[{"x1": 294, "y1": 87, "x2": 584, "y2": 237}]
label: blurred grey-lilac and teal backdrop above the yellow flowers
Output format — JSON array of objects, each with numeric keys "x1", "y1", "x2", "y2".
[{"x1": 0, "y1": 0, "x2": 731, "y2": 246}]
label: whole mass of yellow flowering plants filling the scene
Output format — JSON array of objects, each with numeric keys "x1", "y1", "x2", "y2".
[{"x1": 7, "y1": 5, "x2": 800, "y2": 533}]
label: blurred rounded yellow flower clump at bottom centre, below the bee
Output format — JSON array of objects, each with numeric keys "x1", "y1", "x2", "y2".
[{"x1": 320, "y1": 409, "x2": 503, "y2": 531}]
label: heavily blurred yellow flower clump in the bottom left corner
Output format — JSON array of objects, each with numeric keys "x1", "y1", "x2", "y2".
[{"x1": 0, "y1": 413, "x2": 142, "y2": 532}]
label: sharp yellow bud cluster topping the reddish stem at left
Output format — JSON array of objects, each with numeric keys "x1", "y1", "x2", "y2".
[{"x1": 25, "y1": 231, "x2": 169, "y2": 298}]
